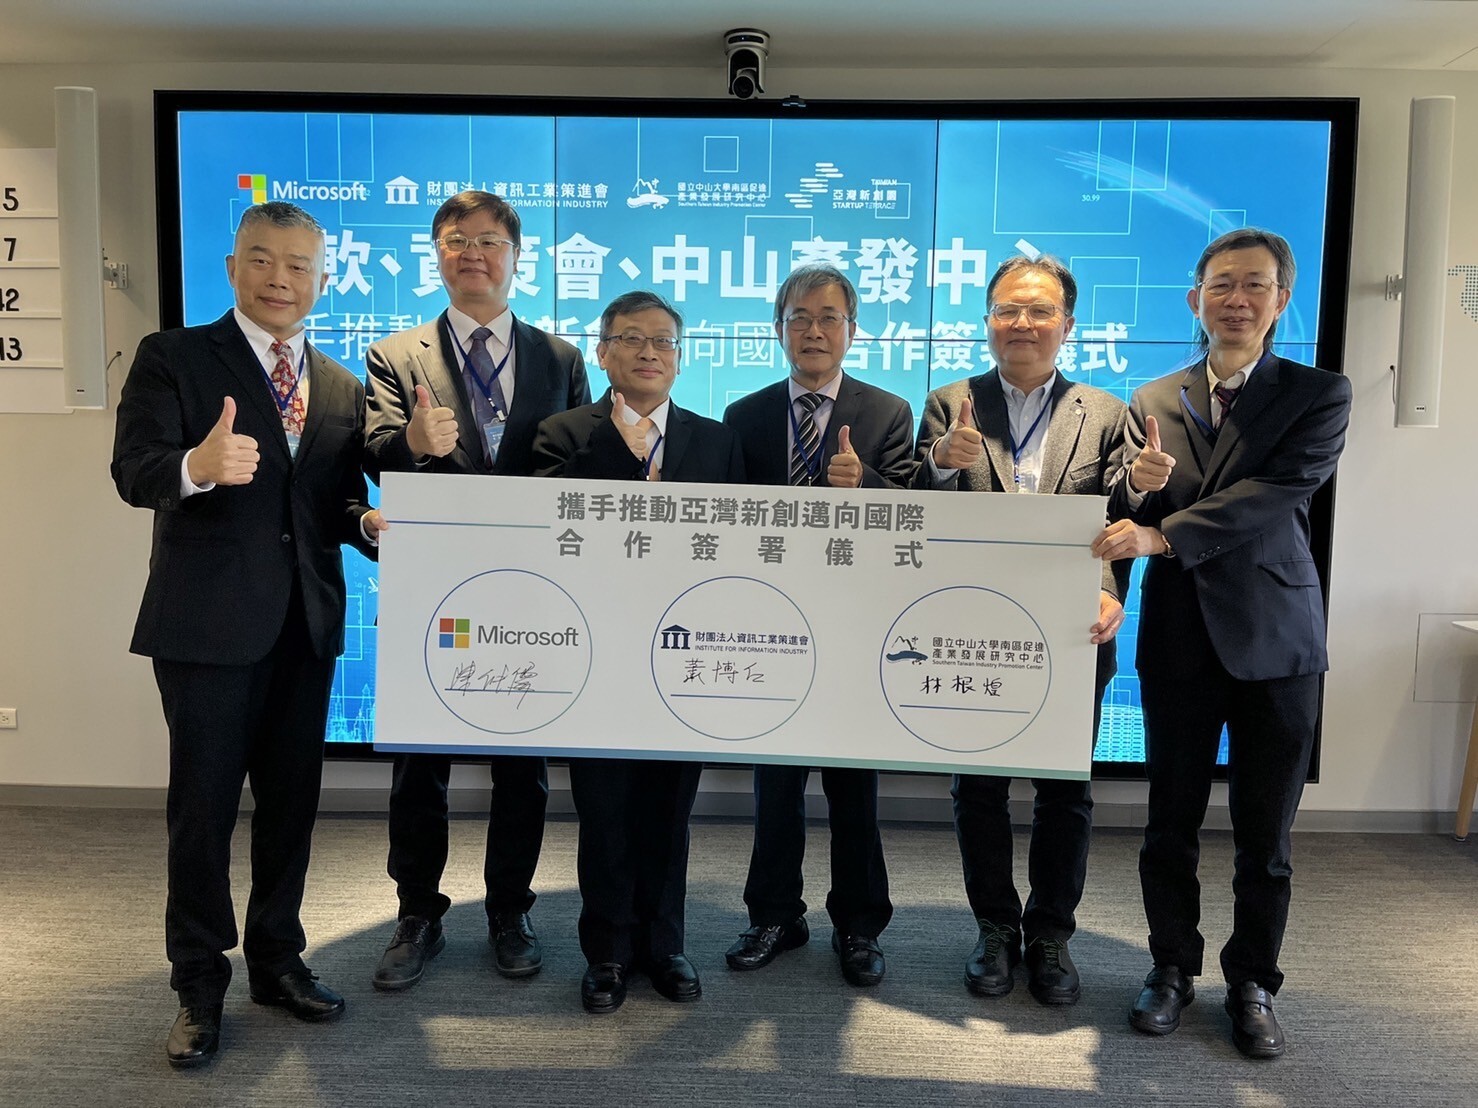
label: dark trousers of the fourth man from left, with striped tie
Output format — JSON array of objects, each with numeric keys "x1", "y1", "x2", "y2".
[{"x1": 743, "y1": 765, "x2": 893, "y2": 938}]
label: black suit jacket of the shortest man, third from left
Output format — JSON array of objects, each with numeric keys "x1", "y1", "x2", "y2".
[{"x1": 534, "y1": 390, "x2": 743, "y2": 485}]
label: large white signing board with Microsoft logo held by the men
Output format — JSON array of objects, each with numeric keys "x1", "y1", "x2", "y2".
[{"x1": 375, "y1": 473, "x2": 1104, "y2": 779}]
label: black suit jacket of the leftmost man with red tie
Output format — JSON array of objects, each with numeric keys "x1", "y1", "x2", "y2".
[{"x1": 112, "y1": 312, "x2": 374, "y2": 665}]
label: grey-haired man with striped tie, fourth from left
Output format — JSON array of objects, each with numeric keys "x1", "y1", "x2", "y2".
[{"x1": 724, "y1": 264, "x2": 913, "y2": 985}]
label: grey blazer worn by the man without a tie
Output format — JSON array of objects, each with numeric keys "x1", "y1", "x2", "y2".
[{"x1": 913, "y1": 369, "x2": 1131, "y2": 684}]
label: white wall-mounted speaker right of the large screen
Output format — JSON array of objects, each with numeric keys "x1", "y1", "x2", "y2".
[{"x1": 1395, "y1": 96, "x2": 1457, "y2": 427}]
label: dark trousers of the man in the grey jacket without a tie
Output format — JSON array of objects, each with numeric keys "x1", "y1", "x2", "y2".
[{"x1": 949, "y1": 684, "x2": 1106, "y2": 943}]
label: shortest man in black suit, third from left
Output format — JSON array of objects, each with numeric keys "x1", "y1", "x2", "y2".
[{"x1": 534, "y1": 291, "x2": 743, "y2": 1013}]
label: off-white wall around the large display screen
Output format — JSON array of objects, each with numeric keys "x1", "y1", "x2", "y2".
[{"x1": 0, "y1": 64, "x2": 1478, "y2": 826}]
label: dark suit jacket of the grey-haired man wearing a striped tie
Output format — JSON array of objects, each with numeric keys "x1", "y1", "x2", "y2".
[{"x1": 724, "y1": 375, "x2": 913, "y2": 489}]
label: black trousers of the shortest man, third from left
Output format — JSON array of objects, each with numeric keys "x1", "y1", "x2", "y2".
[{"x1": 569, "y1": 758, "x2": 702, "y2": 966}]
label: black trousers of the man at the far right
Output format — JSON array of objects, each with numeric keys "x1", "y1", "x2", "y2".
[{"x1": 1140, "y1": 644, "x2": 1320, "y2": 993}]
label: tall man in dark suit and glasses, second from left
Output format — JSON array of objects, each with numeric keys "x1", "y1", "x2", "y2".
[{"x1": 365, "y1": 191, "x2": 590, "y2": 990}]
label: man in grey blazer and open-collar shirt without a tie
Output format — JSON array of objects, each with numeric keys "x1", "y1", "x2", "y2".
[{"x1": 915, "y1": 256, "x2": 1129, "y2": 1005}]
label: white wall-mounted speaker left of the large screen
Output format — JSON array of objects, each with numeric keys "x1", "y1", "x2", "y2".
[{"x1": 55, "y1": 89, "x2": 107, "y2": 408}]
